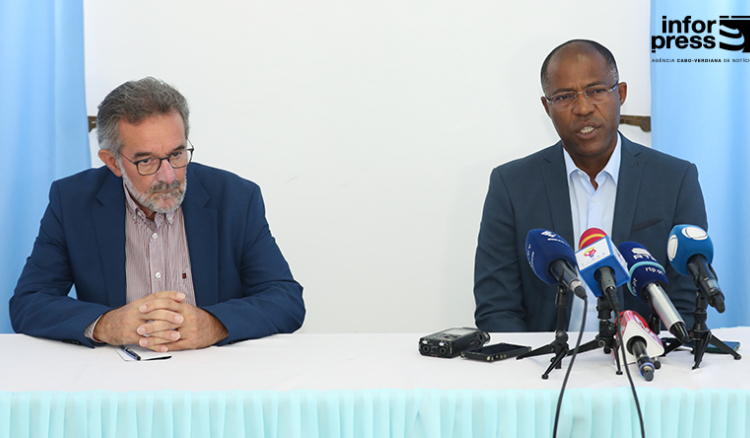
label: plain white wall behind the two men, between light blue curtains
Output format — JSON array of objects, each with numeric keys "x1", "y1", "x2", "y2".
[{"x1": 84, "y1": 0, "x2": 651, "y2": 333}]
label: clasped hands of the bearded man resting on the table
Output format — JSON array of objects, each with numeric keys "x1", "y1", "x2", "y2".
[{"x1": 94, "y1": 291, "x2": 228, "y2": 352}]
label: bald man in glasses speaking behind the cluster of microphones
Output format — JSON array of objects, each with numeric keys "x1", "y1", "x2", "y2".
[{"x1": 474, "y1": 40, "x2": 708, "y2": 332}]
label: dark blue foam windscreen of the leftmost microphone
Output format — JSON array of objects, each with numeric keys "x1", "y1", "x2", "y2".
[{"x1": 526, "y1": 229, "x2": 576, "y2": 284}]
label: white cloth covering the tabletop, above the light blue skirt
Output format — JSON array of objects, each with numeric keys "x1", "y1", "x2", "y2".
[{"x1": 0, "y1": 328, "x2": 750, "y2": 392}]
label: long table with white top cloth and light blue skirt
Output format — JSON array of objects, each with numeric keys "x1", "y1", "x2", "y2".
[{"x1": 0, "y1": 328, "x2": 750, "y2": 438}]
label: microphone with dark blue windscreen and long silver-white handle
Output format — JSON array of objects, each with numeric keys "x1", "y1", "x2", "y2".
[{"x1": 619, "y1": 242, "x2": 690, "y2": 344}]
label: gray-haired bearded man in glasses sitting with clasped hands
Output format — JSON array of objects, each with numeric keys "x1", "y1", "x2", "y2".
[{"x1": 10, "y1": 78, "x2": 305, "y2": 352}]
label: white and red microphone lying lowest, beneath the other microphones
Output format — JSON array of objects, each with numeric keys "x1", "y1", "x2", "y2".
[{"x1": 620, "y1": 310, "x2": 664, "y2": 382}]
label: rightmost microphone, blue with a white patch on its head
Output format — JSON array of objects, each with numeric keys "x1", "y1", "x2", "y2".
[{"x1": 667, "y1": 225, "x2": 726, "y2": 313}]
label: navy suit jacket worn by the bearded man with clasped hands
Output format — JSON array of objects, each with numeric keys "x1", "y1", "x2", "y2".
[{"x1": 10, "y1": 163, "x2": 305, "y2": 346}]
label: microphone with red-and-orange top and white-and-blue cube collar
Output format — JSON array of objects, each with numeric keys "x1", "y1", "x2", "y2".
[{"x1": 576, "y1": 228, "x2": 630, "y2": 311}]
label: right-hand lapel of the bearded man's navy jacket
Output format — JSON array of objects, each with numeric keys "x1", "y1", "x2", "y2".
[{"x1": 182, "y1": 164, "x2": 219, "y2": 307}]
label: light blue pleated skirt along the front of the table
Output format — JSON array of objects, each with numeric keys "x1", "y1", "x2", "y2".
[{"x1": 0, "y1": 390, "x2": 750, "y2": 438}]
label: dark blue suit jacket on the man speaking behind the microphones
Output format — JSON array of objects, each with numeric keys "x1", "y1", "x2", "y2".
[{"x1": 474, "y1": 136, "x2": 708, "y2": 332}]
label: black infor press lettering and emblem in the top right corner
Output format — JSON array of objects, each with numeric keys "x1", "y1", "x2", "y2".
[{"x1": 651, "y1": 15, "x2": 750, "y2": 53}]
